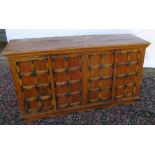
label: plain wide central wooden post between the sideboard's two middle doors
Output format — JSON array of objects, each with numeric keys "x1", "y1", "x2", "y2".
[{"x1": 82, "y1": 52, "x2": 88, "y2": 104}]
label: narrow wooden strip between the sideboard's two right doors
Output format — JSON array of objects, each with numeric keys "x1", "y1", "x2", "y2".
[{"x1": 112, "y1": 51, "x2": 118, "y2": 104}]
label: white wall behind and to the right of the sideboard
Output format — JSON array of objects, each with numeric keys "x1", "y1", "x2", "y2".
[{"x1": 6, "y1": 29, "x2": 155, "y2": 67}]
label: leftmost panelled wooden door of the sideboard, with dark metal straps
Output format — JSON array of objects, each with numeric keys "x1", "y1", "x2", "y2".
[{"x1": 15, "y1": 56, "x2": 54, "y2": 114}]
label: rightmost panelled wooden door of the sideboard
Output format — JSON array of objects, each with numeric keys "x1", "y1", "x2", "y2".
[{"x1": 115, "y1": 49, "x2": 145, "y2": 100}]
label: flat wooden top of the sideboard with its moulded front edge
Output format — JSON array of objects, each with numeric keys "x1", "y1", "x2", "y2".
[{"x1": 3, "y1": 34, "x2": 150, "y2": 55}]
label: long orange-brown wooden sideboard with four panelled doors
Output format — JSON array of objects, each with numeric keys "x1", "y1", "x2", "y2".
[{"x1": 3, "y1": 34, "x2": 150, "y2": 121}]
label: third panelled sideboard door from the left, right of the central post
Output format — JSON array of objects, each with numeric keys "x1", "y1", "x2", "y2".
[{"x1": 88, "y1": 51, "x2": 114, "y2": 103}]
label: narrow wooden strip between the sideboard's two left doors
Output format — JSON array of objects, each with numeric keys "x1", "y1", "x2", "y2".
[{"x1": 48, "y1": 55, "x2": 57, "y2": 111}]
